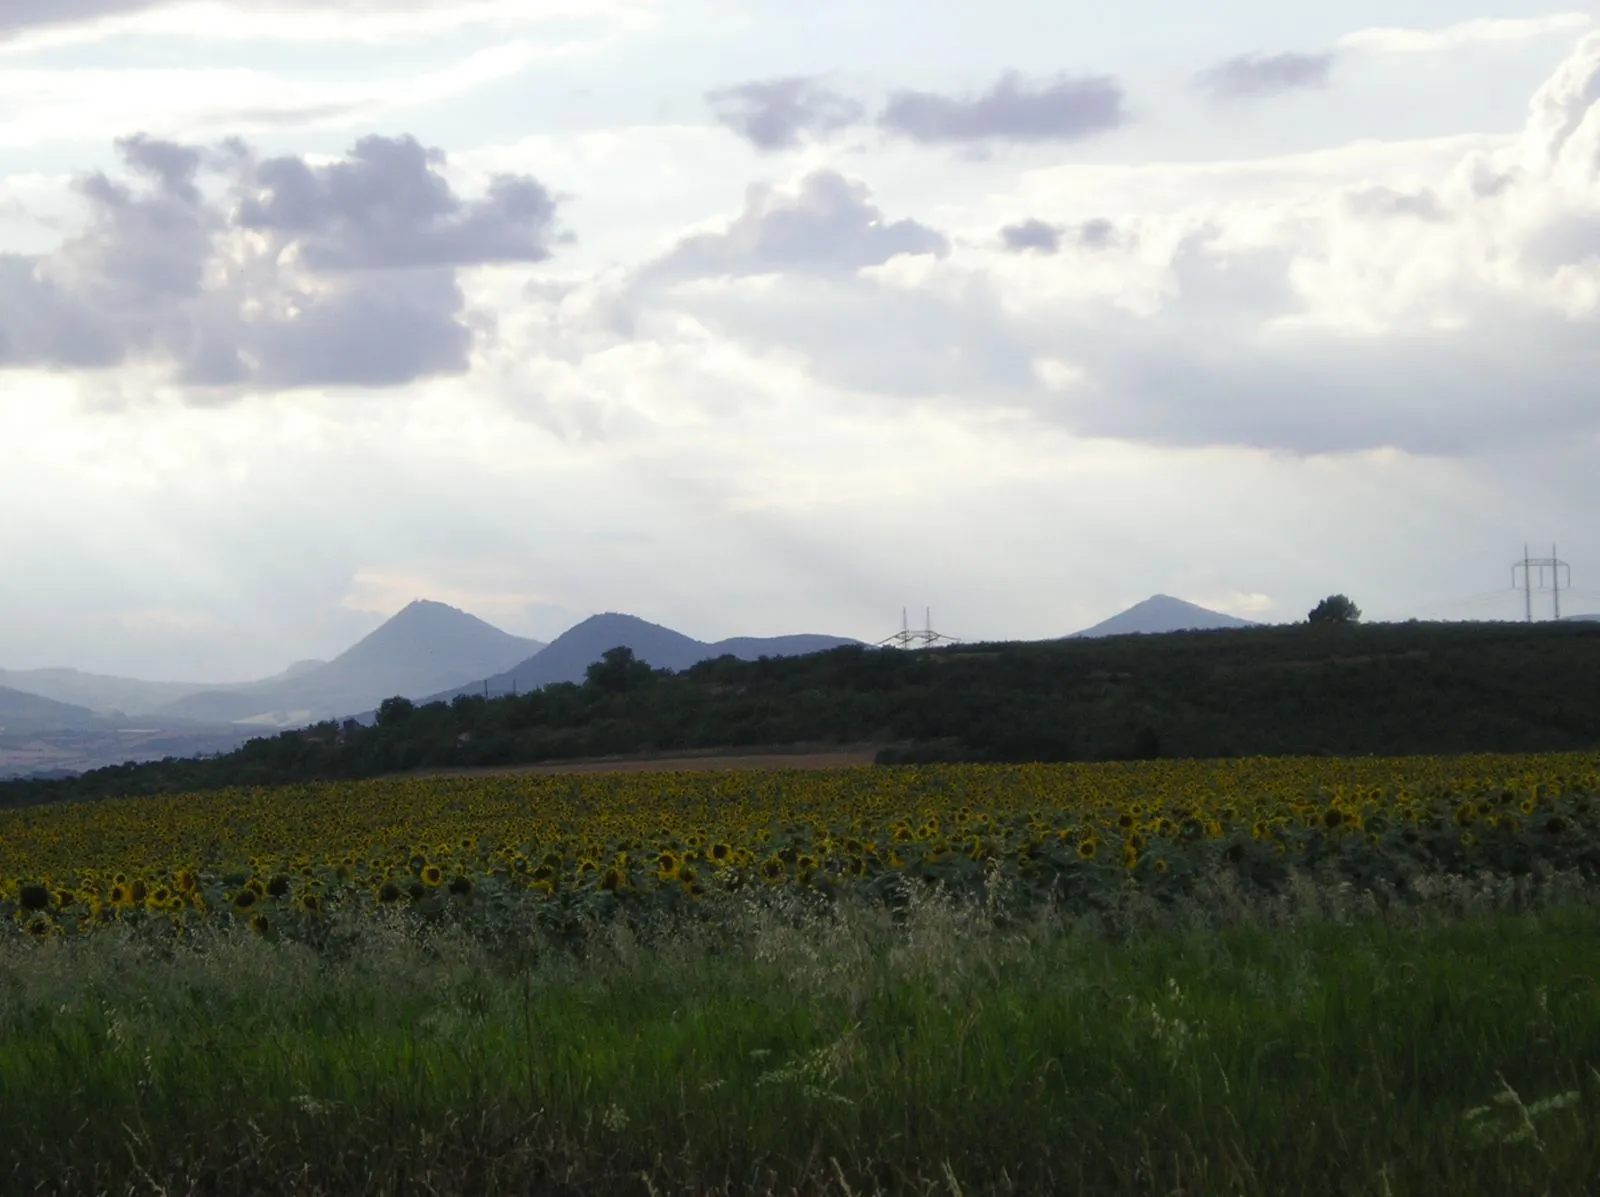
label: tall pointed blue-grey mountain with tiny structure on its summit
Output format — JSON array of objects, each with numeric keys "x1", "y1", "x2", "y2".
[{"x1": 163, "y1": 600, "x2": 544, "y2": 727}]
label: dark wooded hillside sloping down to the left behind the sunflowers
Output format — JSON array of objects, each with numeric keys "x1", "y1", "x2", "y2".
[{"x1": 0, "y1": 619, "x2": 1600, "y2": 805}]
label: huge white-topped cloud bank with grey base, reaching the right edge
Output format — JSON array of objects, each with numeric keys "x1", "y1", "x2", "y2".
[{"x1": 614, "y1": 35, "x2": 1600, "y2": 456}]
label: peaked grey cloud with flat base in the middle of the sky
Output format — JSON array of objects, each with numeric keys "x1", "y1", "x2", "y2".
[{"x1": 645, "y1": 170, "x2": 950, "y2": 278}]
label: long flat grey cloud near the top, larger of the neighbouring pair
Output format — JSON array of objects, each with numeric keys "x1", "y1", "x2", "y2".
[{"x1": 878, "y1": 72, "x2": 1128, "y2": 144}]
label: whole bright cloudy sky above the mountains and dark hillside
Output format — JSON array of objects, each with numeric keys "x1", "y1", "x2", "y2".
[{"x1": 0, "y1": 0, "x2": 1600, "y2": 682}]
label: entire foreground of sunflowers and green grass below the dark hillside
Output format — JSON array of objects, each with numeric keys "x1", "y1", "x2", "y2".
[{"x1": 0, "y1": 754, "x2": 1600, "y2": 1194}]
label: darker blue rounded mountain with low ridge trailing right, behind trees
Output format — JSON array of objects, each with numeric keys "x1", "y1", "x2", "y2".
[{"x1": 429, "y1": 613, "x2": 859, "y2": 701}]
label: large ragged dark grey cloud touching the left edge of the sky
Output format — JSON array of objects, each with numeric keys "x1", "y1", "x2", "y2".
[{"x1": 0, "y1": 136, "x2": 555, "y2": 389}]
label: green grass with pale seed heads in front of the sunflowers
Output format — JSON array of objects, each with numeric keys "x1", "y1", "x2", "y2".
[{"x1": 0, "y1": 883, "x2": 1600, "y2": 1197}]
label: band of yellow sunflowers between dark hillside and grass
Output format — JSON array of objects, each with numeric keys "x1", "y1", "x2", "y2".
[{"x1": 0, "y1": 754, "x2": 1600, "y2": 938}]
